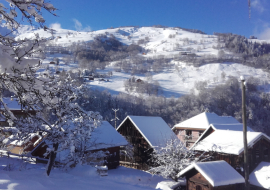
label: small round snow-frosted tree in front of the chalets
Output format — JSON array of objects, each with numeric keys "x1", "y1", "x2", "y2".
[{"x1": 149, "y1": 138, "x2": 210, "y2": 181}]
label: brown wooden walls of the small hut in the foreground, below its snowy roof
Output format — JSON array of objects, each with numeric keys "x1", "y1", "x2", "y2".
[{"x1": 185, "y1": 169, "x2": 244, "y2": 190}]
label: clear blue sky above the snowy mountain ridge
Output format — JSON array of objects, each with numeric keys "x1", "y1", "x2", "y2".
[{"x1": 12, "y1": 0, "x2": 270, "y2": 39}]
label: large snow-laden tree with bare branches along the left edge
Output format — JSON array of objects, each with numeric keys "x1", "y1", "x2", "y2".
[{"x1": 0, "y1": 0, "x2": 101, "y2": 175}]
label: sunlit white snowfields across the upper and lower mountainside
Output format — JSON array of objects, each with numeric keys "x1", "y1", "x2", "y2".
[{"x1": 18, "y1": 27, "x2": 269, "y2": 97}]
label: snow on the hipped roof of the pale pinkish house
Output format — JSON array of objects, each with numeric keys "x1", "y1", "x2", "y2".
[{"x1": 173, "y1": 112, "x2": 243, "y2": 129}]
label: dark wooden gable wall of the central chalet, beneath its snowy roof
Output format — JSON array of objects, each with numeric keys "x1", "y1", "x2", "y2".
[{"x1": 118, "y1": 118, "x2": 153, "y2": 170}]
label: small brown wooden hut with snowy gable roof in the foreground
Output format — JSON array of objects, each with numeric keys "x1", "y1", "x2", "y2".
[{"x1": 178, "y1": 161, "x2": 245, "y2": 190}]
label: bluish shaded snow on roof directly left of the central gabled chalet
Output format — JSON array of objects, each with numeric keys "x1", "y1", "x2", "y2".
[{"x1": 88, "y1": 121, "x2": 128, "y2": 150}]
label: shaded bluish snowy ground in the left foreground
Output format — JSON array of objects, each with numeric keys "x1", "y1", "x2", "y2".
[{"x1": 0, "y1": 158, "x2": 164, "y2": 190}]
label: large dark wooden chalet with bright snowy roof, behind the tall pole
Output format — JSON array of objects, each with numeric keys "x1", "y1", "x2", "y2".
[{"x1": 193, "y1": 125, "x2": 270, "y2": 174}]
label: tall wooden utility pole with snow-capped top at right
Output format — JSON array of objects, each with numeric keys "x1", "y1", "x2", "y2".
[{"x1": 240, "y1": 76, "x2": 250, "y2": 190}]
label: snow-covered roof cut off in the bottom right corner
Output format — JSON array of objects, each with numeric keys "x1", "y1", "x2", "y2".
[{"x1": 249, "y1": 162, "x2": 270, "y2": 189}]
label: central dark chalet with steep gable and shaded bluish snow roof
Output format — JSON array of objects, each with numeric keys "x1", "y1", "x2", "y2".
[{"x1": 117, "y1": 116, "x2": 177, "y2": 170}]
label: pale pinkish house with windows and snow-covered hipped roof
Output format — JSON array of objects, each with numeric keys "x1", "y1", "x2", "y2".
[{"x1": 172, "y1": 112, "x2": 253, "y2": 147}]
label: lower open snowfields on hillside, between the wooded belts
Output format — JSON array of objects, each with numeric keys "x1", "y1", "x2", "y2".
[{"x1": 43, "y1": 60, "x2": 270, "y2": 98}]
